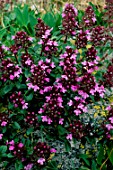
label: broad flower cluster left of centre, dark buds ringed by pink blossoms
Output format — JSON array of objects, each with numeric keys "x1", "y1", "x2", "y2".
[{"x1": 27, "y1": 59, "x2": 55, "y2": 94}]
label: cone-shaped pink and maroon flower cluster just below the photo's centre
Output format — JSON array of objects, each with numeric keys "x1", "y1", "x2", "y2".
[{"x1": 38, "y1": 85, "x2": 64, "y2": 125}]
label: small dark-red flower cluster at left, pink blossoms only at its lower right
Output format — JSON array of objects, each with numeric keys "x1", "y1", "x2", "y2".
[{"x1": 10, "y1": 91, "x2": 28, "y2": 109}]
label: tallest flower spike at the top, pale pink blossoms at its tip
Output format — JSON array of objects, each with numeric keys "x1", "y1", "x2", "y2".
[{"x1": 61, "y1": 4, "x2": 78, "y2": 36}]
